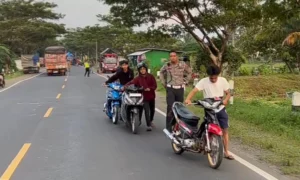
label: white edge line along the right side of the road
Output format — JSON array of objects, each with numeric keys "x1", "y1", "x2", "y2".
[{"x1": 97, "y1": 73, "x2": 278, "y2": 180}]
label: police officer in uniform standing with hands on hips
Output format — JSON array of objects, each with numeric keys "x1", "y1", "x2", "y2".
[{"x1": 159, "y1": 51, "x2": 192, "y2": 132}]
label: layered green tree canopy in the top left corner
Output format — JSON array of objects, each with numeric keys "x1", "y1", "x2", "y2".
[{"x1": 0, "y1": 0, "x2": 65, "y2": 53}]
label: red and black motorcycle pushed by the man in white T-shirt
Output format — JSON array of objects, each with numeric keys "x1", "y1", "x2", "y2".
[{"x1": 163, "y1": 99, "x2": 224, "y2": 169}]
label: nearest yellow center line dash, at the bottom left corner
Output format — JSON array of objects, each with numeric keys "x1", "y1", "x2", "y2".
[{"x1": 0, "y1": 143, "x2": 31, "y2": 180}]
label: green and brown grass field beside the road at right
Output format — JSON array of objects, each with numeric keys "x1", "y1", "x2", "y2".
[{"x1": 158, "y1": 75, "x2": 300, "y2": 175}]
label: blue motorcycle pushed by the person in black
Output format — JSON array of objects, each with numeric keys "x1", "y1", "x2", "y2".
[{"x1": 104, "y1": 82, "x2": 123, "y2": 124}]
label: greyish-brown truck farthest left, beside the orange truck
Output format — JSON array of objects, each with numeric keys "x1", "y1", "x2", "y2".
[{"x1": 21, "y1": 55, "x2": 40, "y2": 74}]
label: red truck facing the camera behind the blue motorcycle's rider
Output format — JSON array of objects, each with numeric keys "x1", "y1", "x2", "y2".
[{"x1": 100, "y1": 53, "x2": 119, "y2": 73}]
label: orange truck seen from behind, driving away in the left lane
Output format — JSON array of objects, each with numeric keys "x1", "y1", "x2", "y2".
[{"x1": 44, "y1": 46, "x2": 68, "y2": 76}]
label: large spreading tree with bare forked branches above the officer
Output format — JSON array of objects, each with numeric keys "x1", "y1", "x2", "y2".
[{"x1": 99, "y1": 0, "x2": 261, "y2": 67}]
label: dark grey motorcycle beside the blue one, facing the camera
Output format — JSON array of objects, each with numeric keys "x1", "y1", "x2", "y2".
[{"x1": 121, "y1": 85, "x2": 144, "y2": 134}]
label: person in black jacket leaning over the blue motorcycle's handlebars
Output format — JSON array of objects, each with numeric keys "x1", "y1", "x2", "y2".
[{"x1": 104, "y1": 60, "x2": 134, "y2": 85}]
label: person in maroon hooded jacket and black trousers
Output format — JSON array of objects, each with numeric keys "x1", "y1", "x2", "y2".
[{"x1": 124, "y1": 62, "x2": 157, "y2": 131}]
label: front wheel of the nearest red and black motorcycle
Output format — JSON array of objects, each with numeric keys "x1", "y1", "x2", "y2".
[{"x1": 207, "y1": 134, "x2": 224, "y2": 169}]
